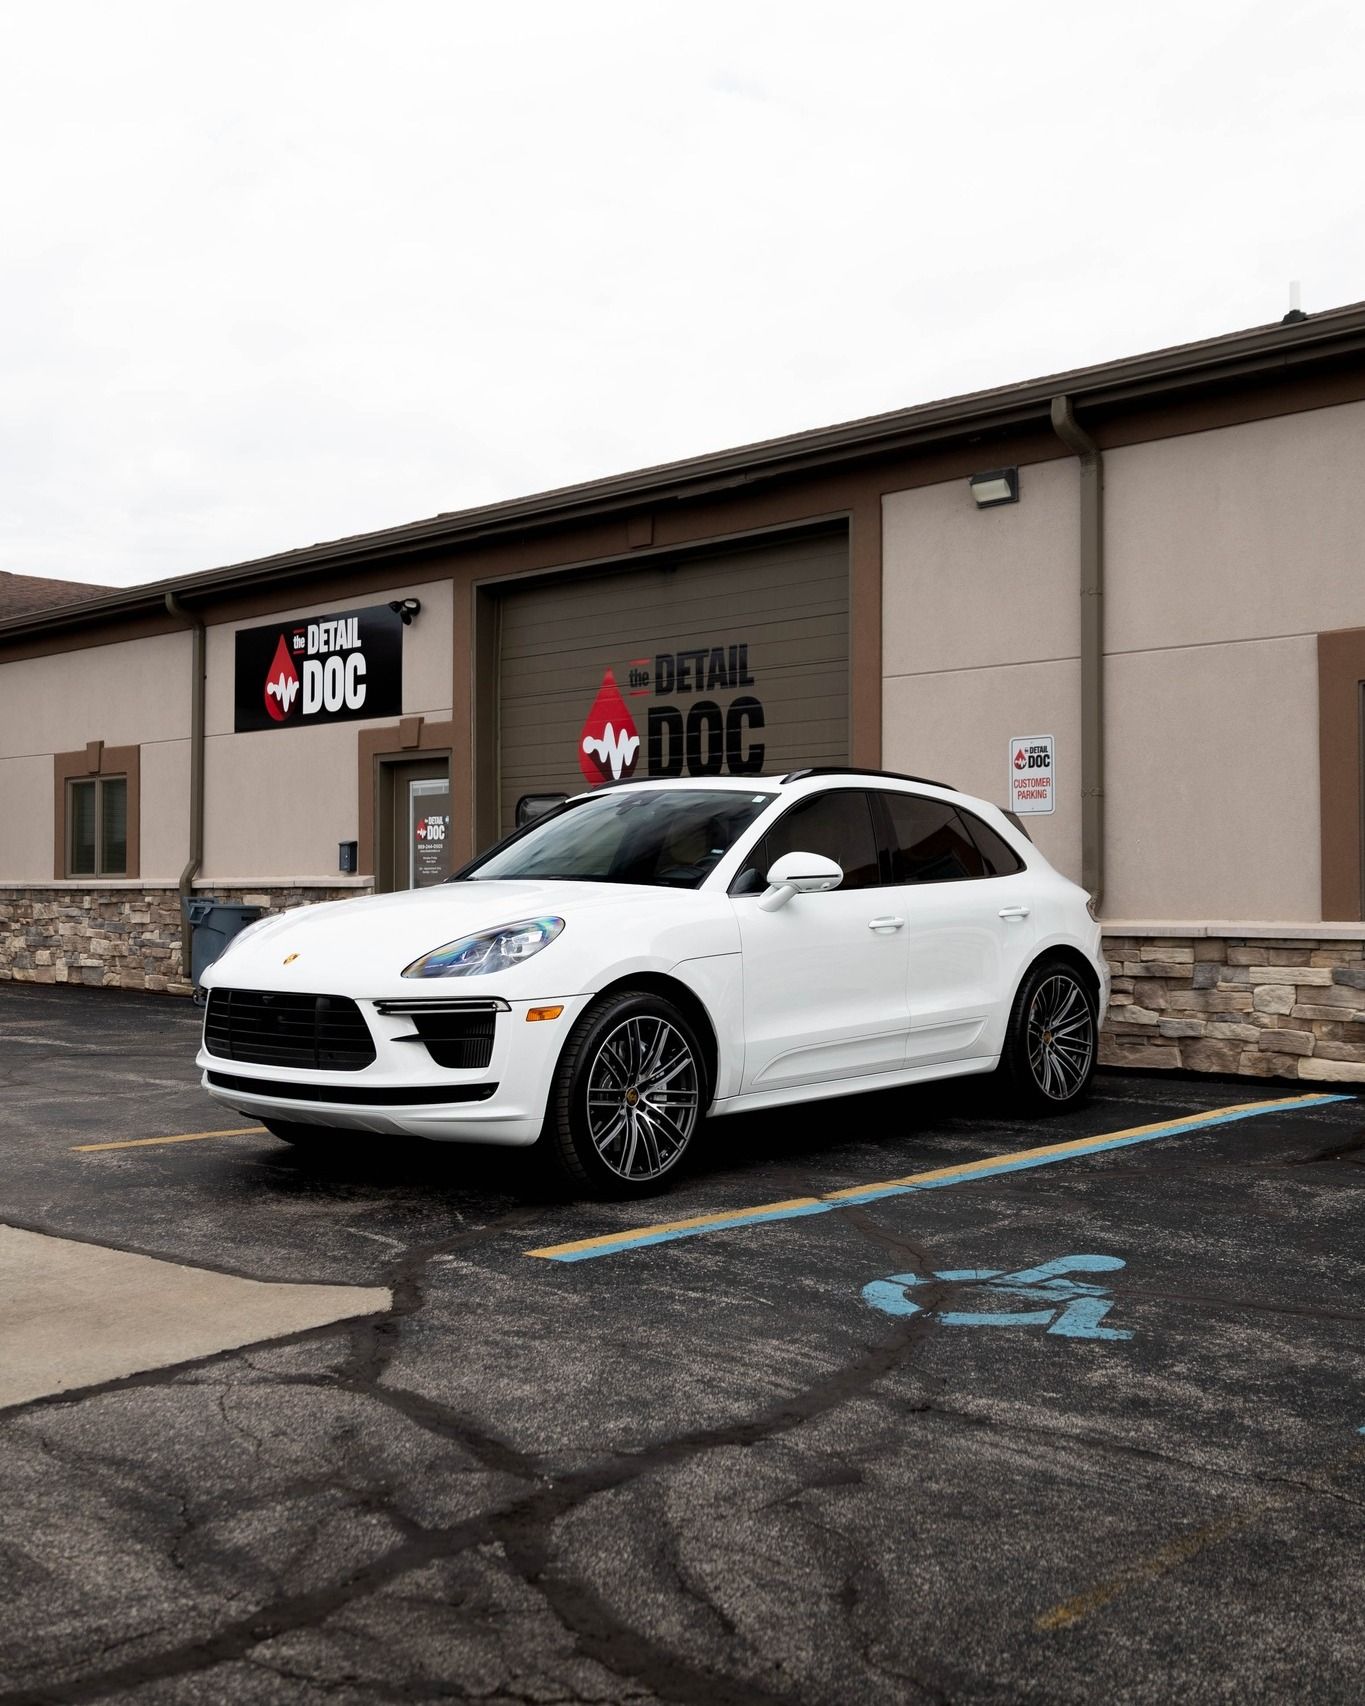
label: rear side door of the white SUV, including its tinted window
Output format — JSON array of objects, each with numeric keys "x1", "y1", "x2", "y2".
[{"x1": 877, "y1": 790, "x2": 1036, "y2": 1066}]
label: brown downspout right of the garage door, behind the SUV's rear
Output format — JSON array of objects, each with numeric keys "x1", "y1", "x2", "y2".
[{"x1": 1053, "y1": 396, "x2": 1104, "y2": 913}]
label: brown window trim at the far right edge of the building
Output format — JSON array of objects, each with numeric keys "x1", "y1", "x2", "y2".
[{"x1": 1317, "y1": 628, "x2": 1365, "y2": 921}]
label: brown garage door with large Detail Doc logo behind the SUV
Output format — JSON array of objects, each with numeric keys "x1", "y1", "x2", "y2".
[{"x1": 498, "y1": 529, "x2": 848, "y2": 831}]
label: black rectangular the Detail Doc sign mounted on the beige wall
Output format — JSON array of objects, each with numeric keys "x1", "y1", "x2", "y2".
[{"x1": 232, "y1": 604, "x2": 403, "y2": 734}]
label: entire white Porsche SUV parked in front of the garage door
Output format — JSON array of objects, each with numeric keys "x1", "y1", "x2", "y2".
[{"x1": 198, "y1": 769, "x2": 1109, "y2": 1196}]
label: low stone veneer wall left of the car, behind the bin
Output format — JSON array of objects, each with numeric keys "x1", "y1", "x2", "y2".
[{"x1": 0, "y1": 884, "x2": 369, "y2": 995}]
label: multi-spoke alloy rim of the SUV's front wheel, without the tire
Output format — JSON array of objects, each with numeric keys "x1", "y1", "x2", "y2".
[{"x1": 587, "y1": 1013, "x2": 701, "y2": 1184}]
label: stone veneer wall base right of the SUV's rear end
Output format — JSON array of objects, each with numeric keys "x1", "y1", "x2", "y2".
[{"x1": 1099, "y1": 925, "x2": 1365, "y2": 1083}]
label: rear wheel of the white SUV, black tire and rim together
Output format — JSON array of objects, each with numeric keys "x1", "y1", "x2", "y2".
[{"x1": 1000, "y1": 959, "x2": 1099, "y2": 1114}]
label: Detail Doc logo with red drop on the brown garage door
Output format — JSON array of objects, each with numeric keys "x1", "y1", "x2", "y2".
[{"x1": 578, "y1": 643, "x2": 764, "y2": 786}]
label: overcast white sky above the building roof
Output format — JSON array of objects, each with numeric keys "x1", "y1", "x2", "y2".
[{"x1": 0, "y1": 0, "x2": 1365, "y2": 583}]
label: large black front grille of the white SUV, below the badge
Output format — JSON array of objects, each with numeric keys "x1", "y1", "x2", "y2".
[{"x1": 203, "y1": 989, "x2": 375, "y2": 1071}]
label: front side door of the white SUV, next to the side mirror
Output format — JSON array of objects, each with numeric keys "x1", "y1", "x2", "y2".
[{"x1": 730, "y1": 788, "x2": 909, "y2": 1092}]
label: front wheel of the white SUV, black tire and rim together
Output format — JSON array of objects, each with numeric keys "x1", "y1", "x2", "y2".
[{"x1": 537, "y1": 989, "x2": 710, "y2": 1199}]
